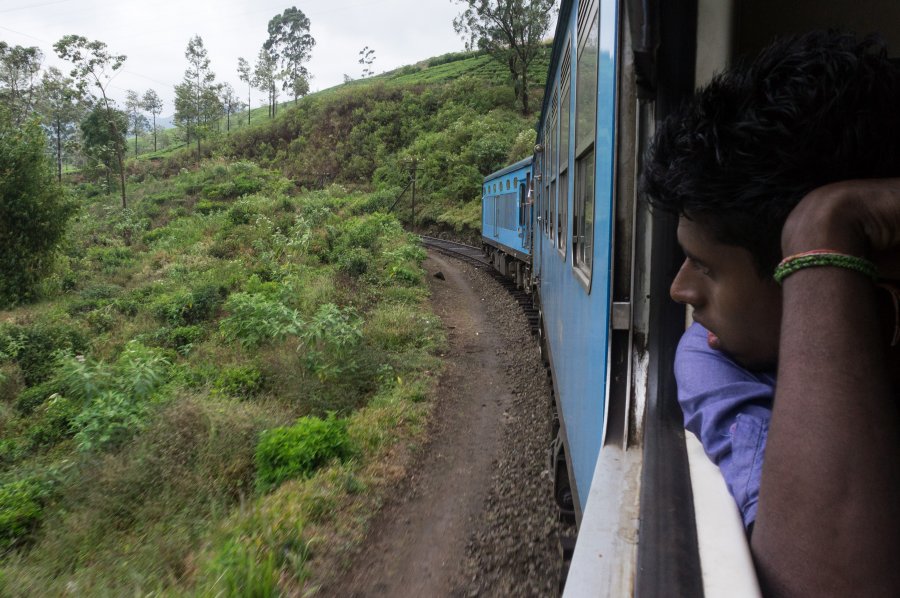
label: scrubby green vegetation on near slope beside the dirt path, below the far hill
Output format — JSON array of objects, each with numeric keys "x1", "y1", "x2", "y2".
[{"x1": 0, "y1": 160, "x2": 444, "y2": 595}]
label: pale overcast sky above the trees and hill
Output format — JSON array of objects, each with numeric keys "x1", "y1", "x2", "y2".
[{"x1": 0, "y1": 0, "x2": 472, "y2": 116}]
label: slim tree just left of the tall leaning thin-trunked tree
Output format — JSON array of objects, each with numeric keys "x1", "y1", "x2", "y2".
[{"x1": 38, "y1": 66, "x2": 85, "y2": 182}]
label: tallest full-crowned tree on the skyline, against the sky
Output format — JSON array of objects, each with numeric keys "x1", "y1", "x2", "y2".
[{"x1": 263, "y1": 6, "x2": 316, "y2": 103}]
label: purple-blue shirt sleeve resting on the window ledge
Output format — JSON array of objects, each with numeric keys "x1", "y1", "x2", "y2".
[{"x1": 675, "y1": 323, "x2": 775, "y2": 527}]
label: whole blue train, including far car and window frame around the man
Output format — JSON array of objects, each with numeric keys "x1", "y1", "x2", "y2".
[{"x1": 483, "y1": 0, "x2": 900, "y2": 597}]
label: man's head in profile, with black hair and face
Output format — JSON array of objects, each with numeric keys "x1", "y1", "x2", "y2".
[{"x1": 642, "y1": 32, "x2": 900, "y2": 367}]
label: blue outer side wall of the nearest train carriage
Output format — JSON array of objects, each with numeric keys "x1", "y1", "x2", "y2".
[{"x1": 533, "y1": 0, "x2": 618, "y2": 513}]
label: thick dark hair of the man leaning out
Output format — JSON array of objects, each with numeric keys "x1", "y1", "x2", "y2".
[{"x1": 641, "y1": 31, "x2": 900, "y2": 276}]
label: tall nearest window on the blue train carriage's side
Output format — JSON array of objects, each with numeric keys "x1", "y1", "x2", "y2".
[{"x1": 572, "y1": 0, "x2": 600, "y2": 281}]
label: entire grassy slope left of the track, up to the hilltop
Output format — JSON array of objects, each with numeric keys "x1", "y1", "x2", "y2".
[{"x1": 0, "y1": 45, "x2": 546, "y2": 595}]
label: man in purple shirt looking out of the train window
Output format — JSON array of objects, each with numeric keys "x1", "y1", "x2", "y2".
[{"x1": 643, "y1": 32, "x2": 900, "y2": 596}]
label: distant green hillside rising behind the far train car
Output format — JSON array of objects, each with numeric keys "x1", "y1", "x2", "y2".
[{"x1": 148, "y1": 46, "x2": 550, "y2": 238}]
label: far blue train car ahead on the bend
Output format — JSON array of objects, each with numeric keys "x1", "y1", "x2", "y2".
[{"x1": 481, "y1": 156, "x2": 534, "y2": 286}]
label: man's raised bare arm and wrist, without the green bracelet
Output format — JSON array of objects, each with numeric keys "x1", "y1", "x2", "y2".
[{"x1": 752, "y1": 181, "x2": 900, "y2": 596}]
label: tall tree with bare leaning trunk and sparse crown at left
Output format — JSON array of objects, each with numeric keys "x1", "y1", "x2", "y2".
[{"x1": 53, "y1": 35, "x2": 127, "y2": 208}]
